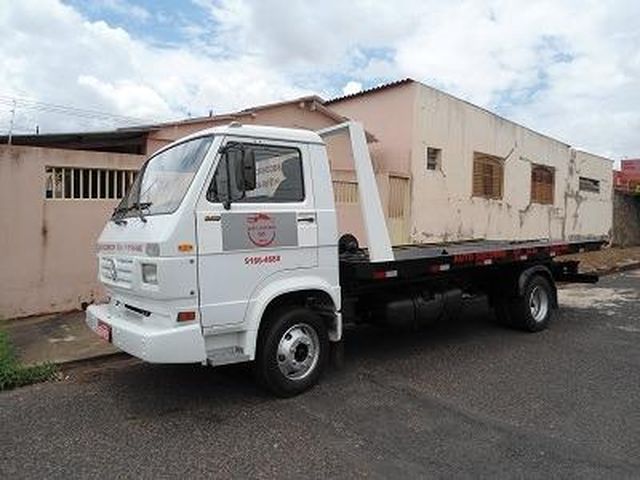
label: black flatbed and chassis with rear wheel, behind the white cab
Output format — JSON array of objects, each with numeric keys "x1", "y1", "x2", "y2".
[{"x1": 339, "y1": 235, "x2": 606, "y2": 332}]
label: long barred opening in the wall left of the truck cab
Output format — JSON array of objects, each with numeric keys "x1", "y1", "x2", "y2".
[{"x1": 44, "y1": 167, "x2": 137, "y2": 200}]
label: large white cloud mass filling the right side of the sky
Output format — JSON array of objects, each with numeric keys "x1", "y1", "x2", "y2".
[{"x1": 201, "y1": 0, "x2": 640, "y2": 156}]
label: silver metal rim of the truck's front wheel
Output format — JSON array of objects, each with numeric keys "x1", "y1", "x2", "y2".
[{"x1": 277, "y1": 323, "x2": 320, "y2": 380}]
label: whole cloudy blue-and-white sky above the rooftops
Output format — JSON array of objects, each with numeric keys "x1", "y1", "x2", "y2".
[{"x1": 0, "y1": 0, "x2": 640, "y2": 159}]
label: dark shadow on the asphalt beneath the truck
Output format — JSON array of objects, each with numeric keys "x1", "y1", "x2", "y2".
[{"x1": 84, "y1": 301, "x2": 520, "y2": 414}]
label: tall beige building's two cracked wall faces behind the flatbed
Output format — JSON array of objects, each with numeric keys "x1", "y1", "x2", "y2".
[{"x1": 329, "y1": 82, "x2": 612, "y2": 244}]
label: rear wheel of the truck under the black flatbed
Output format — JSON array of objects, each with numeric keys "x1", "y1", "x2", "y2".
[{"x1": 505, "y1": 275, "x2": 554, "y2": 332}]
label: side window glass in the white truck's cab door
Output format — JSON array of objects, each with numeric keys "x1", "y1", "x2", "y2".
[{"x1": 207, "y1": 143, "x2": 304, "y2": 203}]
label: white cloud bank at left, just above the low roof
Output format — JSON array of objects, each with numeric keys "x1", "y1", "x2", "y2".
[{"x1": 0, "y1": 0, "x2": 309, "y2": 133}]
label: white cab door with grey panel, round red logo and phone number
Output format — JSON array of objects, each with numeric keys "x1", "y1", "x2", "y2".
[{"x1": 196, "y1": 137, "x2": 318, "y2": 333}]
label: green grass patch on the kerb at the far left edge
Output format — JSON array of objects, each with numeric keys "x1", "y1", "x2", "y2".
[{"x1": 0, "y1": 330, "x2": 57, "y2": 391}]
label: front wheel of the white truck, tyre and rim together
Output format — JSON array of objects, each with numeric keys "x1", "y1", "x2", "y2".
[{"x1": 254, "y1": 306, "x2": 329, "y2": 397}]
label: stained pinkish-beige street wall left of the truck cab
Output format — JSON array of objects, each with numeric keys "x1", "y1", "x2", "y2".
[{"x1": 0, "y1": 145, "x2": 143, "y2": 318}]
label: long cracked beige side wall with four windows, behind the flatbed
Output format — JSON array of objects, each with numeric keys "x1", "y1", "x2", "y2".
[{"x1": 411, "y1": 84, "x2": 612, "y2": 242}]
